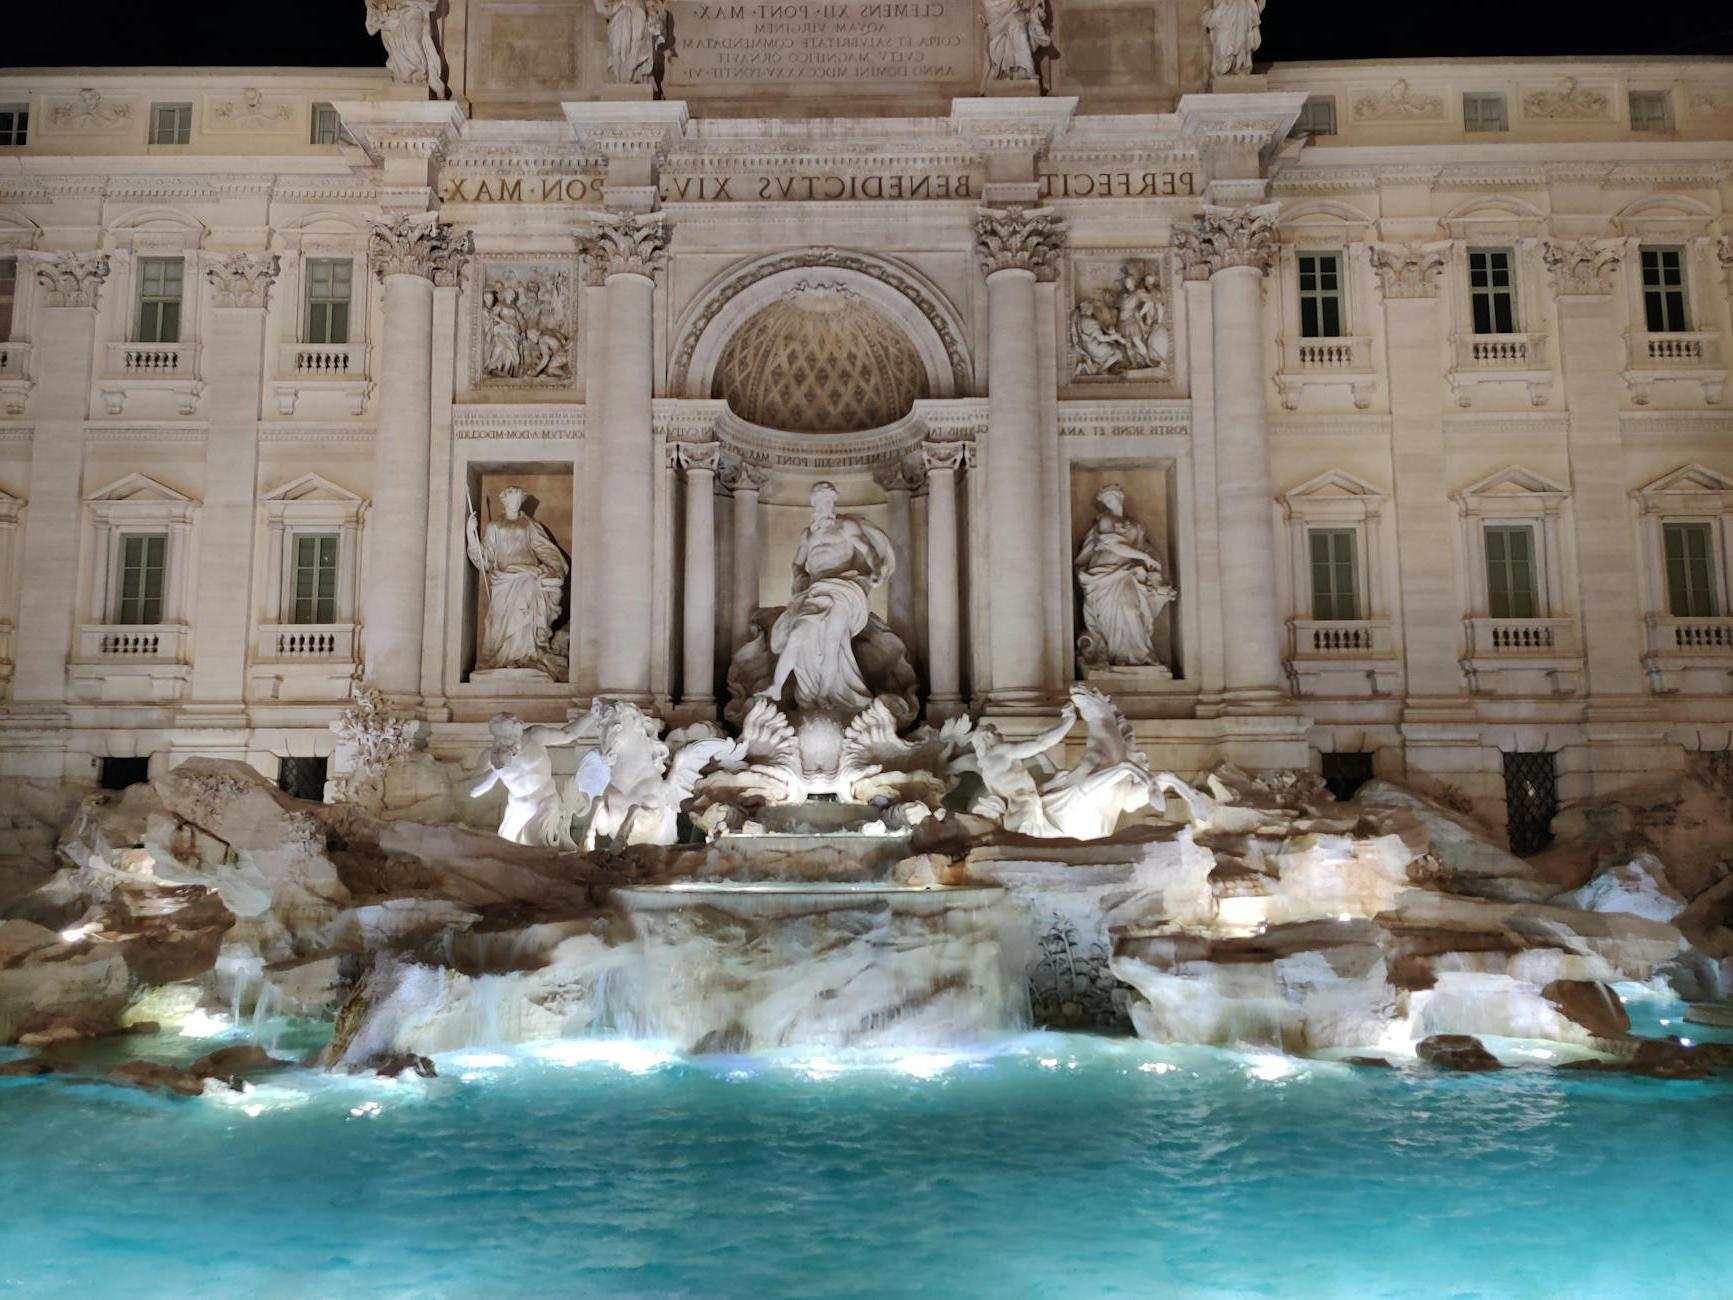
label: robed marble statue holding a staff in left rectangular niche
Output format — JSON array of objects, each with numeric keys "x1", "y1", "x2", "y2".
[{"x1": 466, "y1": 487, "x2": 568, "y2": 681}]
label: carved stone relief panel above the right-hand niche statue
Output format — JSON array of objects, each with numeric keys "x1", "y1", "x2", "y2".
[{"x1": 1071, "y1": 257, "x2": 1173, "y2": 380}]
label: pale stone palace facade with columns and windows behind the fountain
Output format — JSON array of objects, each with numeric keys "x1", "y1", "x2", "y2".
[{"x1": 0, "y1": 0, "x2": 1733, "y2": 846}]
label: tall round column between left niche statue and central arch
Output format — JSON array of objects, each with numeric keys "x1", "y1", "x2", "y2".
[{"x1": 591, "y1": 213, "x2": 667, "y2": 704}]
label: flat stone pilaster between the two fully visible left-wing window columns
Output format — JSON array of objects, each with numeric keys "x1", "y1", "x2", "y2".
[{"x1": 178, "y1": 253, "x2": 282, "y2": 734}]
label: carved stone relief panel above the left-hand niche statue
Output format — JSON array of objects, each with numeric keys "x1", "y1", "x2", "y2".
[{"x1": 470, "y1": 262, "x2": 577, "y2": 387}]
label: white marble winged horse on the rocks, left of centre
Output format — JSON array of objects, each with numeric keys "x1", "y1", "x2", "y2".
[{"x1": 577, "y1": 699, "x2": 745, "y2": 849}]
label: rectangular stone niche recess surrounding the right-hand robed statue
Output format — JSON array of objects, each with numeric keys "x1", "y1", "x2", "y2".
[{"x1": 1066, "y1": 463, "x2": 1185, "y2": 702}]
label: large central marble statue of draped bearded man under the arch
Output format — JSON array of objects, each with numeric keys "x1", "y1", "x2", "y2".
[{"x1": 759, "y1": 482, "x2": 896, "y2": 718}]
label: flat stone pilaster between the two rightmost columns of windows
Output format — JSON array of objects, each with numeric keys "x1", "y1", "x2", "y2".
[{"x1": 1542, "y1": 239, "x2": 1650, "y2": 716}]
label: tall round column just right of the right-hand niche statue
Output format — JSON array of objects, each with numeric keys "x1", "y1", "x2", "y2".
[{"x1": 1175, "y1": 205, "x2": 1284, "y2": 712}]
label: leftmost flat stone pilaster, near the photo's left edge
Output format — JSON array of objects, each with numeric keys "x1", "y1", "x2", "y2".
[{"x1": 10, "y1": 253, "x2": 109, "y2": 714}]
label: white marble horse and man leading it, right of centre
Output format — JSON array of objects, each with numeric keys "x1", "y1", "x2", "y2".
[{"x1": 953, "y1": 683, "x2": 1163, "y2": 839}]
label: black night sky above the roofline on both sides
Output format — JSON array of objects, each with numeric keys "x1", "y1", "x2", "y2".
[{"x1": 0, "y1": 0, "x2": 1733, "y2": 68}]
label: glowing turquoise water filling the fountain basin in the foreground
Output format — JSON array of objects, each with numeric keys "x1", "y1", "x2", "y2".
[{"x1": 0, "y1": 1011, "x2": 1733, "y2": 1300}]
